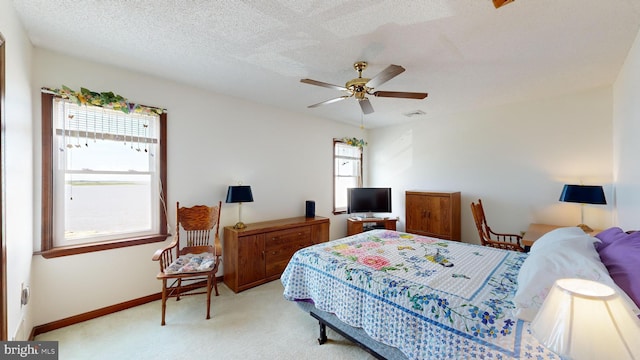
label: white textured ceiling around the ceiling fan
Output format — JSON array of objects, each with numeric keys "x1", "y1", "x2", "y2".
[{"x1": 13, "y1": 0, "x2": 640, "y2": 128}]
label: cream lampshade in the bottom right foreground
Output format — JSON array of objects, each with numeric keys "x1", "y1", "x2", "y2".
[{"x1": 531, "y1": 279, "x2": 640, "y2": 360}]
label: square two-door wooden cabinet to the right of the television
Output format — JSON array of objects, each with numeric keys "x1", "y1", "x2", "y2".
[{"x1": 405, "y1": 191, "x2": 461, "y2": 241}]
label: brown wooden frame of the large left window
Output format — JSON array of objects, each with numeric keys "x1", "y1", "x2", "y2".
[{"x1": 36, "y1": 92, "x2": 169, "y2": 259}]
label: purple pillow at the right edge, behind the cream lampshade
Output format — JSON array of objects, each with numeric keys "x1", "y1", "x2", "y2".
[{"x1": 598, "y1": 232, "x2": 640, "y2": 306}]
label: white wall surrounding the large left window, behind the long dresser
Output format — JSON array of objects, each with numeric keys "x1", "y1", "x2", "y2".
[{"x1": 32, "y1": 49, "x2": 360, "y2": 325}]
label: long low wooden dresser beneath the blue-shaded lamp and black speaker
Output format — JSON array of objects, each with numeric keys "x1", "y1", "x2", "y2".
[{"x1": 222, "y1": 216, "x2": 329, "y2": 293}]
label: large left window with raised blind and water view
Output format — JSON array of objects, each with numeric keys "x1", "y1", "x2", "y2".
[{"x1": 42, "y1": 93, "x2": 167, "y2": 257}]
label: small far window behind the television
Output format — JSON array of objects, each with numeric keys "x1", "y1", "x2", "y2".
[{"x1": 333, "y1": 140, "x2": 362, "y2": 214}]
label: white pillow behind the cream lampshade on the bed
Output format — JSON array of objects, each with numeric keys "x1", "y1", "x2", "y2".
[{"x1": 513, "y1": 233, "x2": 640, "y2": 321}]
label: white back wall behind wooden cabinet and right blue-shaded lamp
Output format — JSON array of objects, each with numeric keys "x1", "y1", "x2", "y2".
[{"x1": 369, "y1": 88, "x2": 612, "y2": 243}]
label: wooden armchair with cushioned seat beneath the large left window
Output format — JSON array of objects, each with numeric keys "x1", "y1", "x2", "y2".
[{"x1": 152, "y1": 201, "x2": 222, "y2": 325}]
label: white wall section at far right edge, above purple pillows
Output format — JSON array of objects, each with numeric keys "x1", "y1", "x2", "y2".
[{"x1": 613, "y1": 27, "x2": 640, "y2": 230}]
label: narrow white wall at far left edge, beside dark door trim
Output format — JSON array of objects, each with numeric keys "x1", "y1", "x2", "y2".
[{"x1": 0, "y1": 1, "x2": 35, "y2": 340}]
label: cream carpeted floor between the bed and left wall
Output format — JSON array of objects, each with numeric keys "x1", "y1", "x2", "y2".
[{"x1": 35, "y1": 280, "x2": 374, "y2": 360}]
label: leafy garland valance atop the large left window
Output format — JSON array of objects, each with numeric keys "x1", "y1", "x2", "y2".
[{"x1": 42, "y1": 85, "x2": 166, "y2": 115}]
